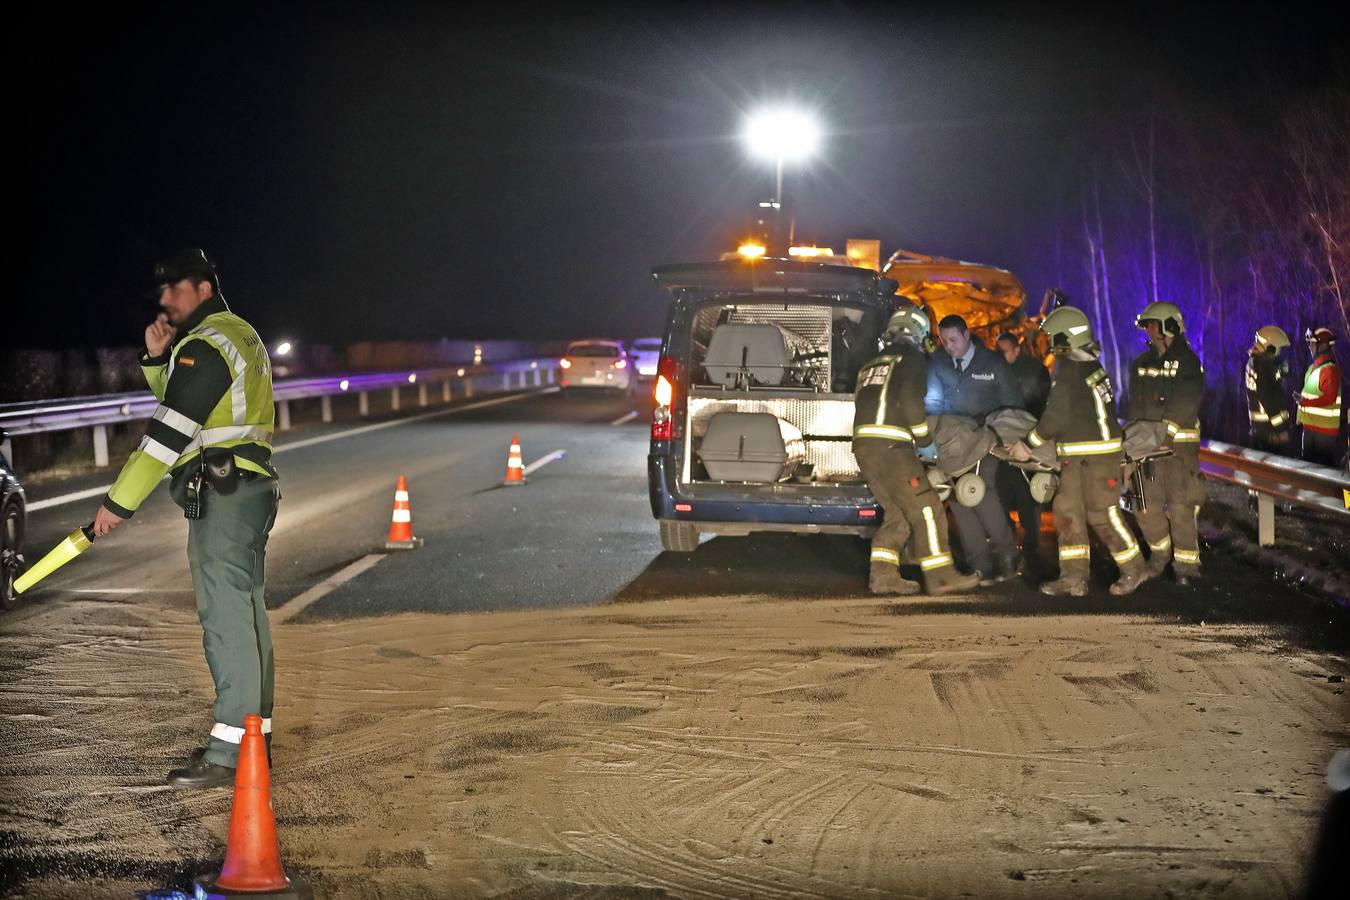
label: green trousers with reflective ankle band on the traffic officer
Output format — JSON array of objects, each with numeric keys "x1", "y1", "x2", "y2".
[{"x1": 188, "y1": 478, "x2": 279, "y2": 766}]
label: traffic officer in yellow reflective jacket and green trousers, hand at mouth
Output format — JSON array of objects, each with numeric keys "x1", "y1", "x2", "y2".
[{"x1": 95, "y1": 250, "x2": 279, "y2": 788}]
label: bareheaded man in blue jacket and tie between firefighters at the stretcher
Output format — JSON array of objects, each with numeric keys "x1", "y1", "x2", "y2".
[{"x1": 923, "y1": 316, "x2": 1026, "y2": 584}]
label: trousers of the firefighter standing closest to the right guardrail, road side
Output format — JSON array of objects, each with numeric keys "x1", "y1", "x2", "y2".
[{"x1": 1134, "y1": 443, "x2": 1204, "y2": 576}]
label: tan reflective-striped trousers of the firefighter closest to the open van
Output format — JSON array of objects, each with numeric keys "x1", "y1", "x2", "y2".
[{"x1": 853, "y1": 437, "x2": 956, "y2": 588}]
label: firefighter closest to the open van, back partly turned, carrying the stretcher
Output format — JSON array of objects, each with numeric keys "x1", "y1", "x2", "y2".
[{"x1": 853, "y1": 306, "x2": 979, "y2": 594}]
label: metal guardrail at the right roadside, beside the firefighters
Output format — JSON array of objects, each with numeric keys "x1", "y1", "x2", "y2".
[{"x1": 1200, "y1": 441, "x2": 1350, "y2": 546}]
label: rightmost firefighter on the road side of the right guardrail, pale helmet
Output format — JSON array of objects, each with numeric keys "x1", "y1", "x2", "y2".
[{"x1": 1129, "y1": 302, "x2": 1204, "y2": 584}]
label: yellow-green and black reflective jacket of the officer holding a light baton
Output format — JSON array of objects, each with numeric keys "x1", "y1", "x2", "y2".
[{"x1": 103, "y1": 297, "x2": 277, "y2": 518}]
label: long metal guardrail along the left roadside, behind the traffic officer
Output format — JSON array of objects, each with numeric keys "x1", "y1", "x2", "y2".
[{"x1": 0, "y1": 356, "x2": 558, "y2": 467}]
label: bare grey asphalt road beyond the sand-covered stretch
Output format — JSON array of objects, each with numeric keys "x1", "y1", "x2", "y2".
[{"x1": 10, "y1": 391, "x2": 1350, "y2": 650}]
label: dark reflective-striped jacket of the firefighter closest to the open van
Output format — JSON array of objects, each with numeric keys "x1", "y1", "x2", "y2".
[{"x1": 853, "y1": 341, "x2": 933, "y2": 447}]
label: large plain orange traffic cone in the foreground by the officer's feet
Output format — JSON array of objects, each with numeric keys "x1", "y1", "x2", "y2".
[{"x1": 193, "y1": 715, "x2": 309, "y2": 897}]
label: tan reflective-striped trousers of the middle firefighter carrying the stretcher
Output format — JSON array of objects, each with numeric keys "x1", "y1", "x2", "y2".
[{"x1": 1053, "y1": 456, "x2": 1143, "y2": 582}]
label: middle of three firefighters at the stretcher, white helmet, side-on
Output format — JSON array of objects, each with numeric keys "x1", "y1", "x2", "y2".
[{"x1": 1013, "y1": 306, "x2": 1148, "y2": 596}]
